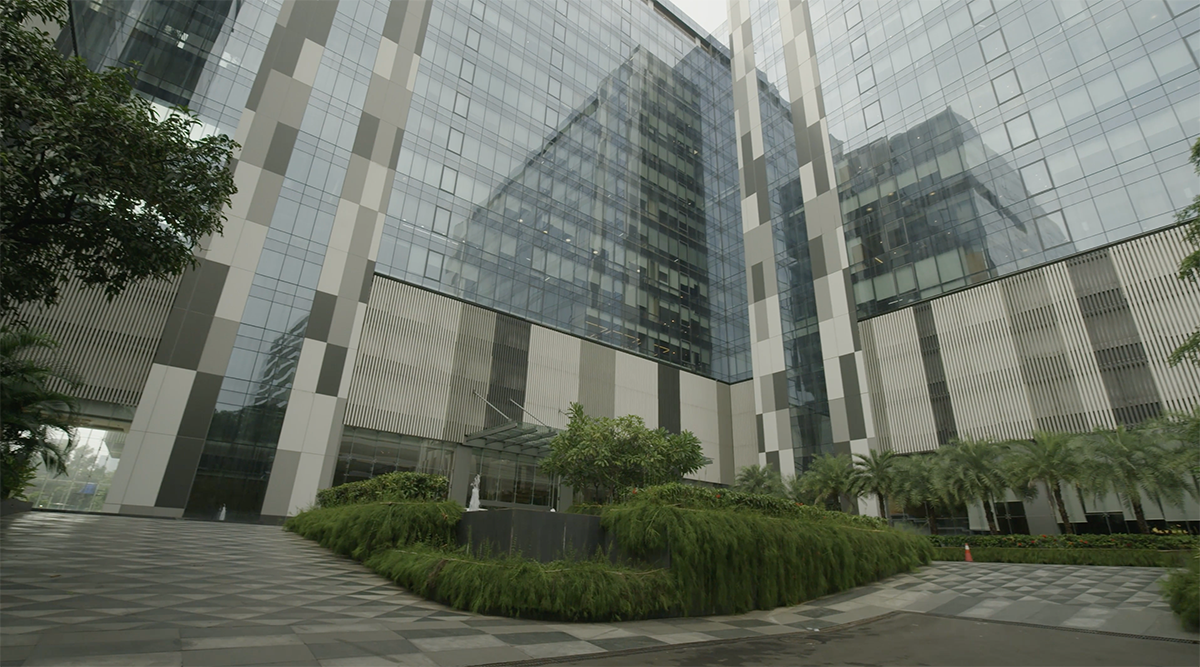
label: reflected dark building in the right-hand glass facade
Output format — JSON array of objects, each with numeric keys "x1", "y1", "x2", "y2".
[{"x1": 834, "y1": 109, "x2": 1075, "y2": 318}]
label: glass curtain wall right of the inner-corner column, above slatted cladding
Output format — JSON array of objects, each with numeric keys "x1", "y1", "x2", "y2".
[{"x1": 810, "y1": 0, "x2": 1200, "y2": 317}]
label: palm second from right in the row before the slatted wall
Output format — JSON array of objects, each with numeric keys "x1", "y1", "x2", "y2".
[{"x1": 1004, "y1": 431, "x2": 1082, "y2": 535}]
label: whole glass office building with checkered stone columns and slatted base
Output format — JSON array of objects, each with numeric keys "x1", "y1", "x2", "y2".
[{"x1": 32, "y1": 0, "x2": 1200, "y2": 521}]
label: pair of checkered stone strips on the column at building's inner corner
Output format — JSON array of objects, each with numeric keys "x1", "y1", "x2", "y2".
[{"x1": 730, "y1": 0, "x2": 875, "y2": 496}]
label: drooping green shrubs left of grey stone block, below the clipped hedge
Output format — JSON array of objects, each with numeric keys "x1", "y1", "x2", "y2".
[{"x1": 283, "y1": 501, "x2": 462, "y2": 560}]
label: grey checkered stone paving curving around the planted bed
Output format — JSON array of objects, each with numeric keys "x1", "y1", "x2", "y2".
[{"x1": 0, "y1": 512, "x2": 1200, "y2": 667}]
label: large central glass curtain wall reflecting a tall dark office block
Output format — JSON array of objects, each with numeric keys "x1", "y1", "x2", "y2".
[{"x1": 377, "y1": 0, "x2": 750, "y2": 381}]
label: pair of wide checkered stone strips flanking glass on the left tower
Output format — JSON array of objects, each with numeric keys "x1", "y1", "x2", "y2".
[{"x1": 104, "y1": 0, "x2": 430, "y2": 517}]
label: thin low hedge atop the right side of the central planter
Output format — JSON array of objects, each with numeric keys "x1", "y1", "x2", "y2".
[{"x1": 624, "y1": 483, "x2": 887, "y2": 530}]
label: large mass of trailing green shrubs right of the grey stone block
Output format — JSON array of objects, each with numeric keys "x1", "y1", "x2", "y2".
[{"x1": 601, "y1": 493, "x2": 934, "y2": 614}]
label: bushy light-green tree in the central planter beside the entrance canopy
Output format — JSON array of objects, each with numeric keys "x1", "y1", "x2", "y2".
[{"x1": 539, "y1": 403, "x2": 709, "y2": 501}]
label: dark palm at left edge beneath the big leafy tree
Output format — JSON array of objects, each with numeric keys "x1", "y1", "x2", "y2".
[{"x1": 0, "y1": 326, "x2": 76, "y2": 499}]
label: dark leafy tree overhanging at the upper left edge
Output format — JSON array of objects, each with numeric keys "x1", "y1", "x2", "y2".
[{"x1": 0, "y1": 0, "x2": 236, "y2": 316}]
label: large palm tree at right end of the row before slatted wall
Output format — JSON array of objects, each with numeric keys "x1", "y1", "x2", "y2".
[{"x1": 1082, "y1": 426, "x2": 1186, "y2": 533}]
